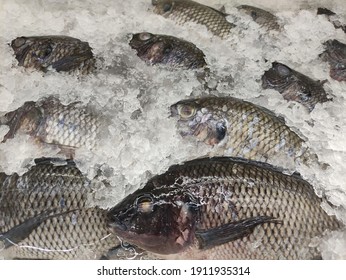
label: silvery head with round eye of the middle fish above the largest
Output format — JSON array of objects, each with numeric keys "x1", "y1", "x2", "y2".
[{"x1": 171, "y1": 98, "x2": 227, "y2": 145}]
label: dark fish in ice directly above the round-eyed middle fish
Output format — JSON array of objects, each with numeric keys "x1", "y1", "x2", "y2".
[{"x1": 130, "y1": 32, "x2": 206, "y2": 69}]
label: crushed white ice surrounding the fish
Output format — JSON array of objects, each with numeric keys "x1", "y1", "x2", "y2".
[{"x1": 0, "y1": 0, "x2": 346, "y2": 259}]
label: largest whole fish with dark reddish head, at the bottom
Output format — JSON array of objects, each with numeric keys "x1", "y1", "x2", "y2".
[{"x1": 108, "y1": 158, "x2": 342, "y2": 259}]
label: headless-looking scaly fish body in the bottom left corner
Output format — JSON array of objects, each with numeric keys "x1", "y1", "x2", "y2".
[{"x1": 0, "y1": 159, "x2": 120, "y2": 259}]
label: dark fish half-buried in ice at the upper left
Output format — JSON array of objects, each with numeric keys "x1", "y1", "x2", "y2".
[{"x1": 11, "y1": 36, "x2": 95, "y2": 74}]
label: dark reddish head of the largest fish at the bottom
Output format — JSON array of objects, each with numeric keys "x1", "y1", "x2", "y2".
[{"x1": 107, "y1": 183, "x2": 197, "y2": 254}]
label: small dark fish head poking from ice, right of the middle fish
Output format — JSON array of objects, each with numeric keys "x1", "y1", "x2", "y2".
[{"x1": 262, "y1": 62, "x2": 331, "y2": 111}]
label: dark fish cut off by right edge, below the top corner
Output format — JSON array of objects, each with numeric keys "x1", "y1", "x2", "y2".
[{"x1": 320, "y1": 40, "x2": 346, "y2": 82}]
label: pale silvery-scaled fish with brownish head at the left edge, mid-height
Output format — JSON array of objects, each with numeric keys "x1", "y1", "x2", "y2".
[{"x1": 0, "y1": 97, "x2": 102, "y2": 154}]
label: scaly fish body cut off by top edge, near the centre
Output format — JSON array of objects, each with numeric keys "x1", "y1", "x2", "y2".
[{"x1": 152, "y1": 0, "x2": 235, "y2": 39}]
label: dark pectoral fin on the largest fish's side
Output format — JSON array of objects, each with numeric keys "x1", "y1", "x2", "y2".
[{"x1": 196, "y1": 216, "x2": 281, "y2": 249}]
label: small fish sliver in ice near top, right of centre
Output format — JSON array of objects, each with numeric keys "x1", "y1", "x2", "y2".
[{"x1": 237, "y1": 5, "x2": 281, "y2": 30}]
